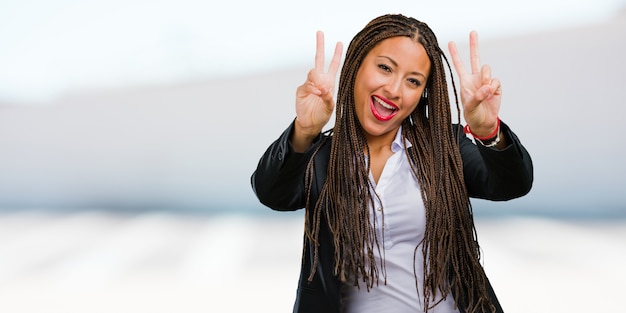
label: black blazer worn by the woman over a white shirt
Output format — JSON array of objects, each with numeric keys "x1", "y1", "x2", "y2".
[{"x1": 251, "y1": 123, "x2": 533, "y2": 313}]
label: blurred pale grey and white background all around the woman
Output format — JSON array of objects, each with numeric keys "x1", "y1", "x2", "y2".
[{"x1": 0, "y1": 0, "x2": 626, "y2": 312}]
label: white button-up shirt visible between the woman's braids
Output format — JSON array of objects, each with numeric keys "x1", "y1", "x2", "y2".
[{"x1": 342, "y1": 128, "x2": 458, "y2": 313}]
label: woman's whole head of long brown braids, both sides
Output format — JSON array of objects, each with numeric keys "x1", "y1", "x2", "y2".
[{"x1": 306, "y1": 15, "x2": 494, "y2": 312}]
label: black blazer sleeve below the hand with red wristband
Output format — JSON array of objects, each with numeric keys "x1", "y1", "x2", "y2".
[{"x1": 457, "y1": 123, "x2": 533, "y2": 201}]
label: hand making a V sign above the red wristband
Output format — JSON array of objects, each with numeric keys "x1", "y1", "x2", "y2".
[{"x1": 448, "y1": 31, "x2": 502, "y2": 137}]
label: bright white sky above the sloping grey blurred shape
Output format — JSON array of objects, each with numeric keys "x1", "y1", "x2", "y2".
[{"x1": 0, "y1": 0, "x2": 625, "y2": 105}]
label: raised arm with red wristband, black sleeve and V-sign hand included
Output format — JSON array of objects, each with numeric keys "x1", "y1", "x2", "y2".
[{"x1": 448, "y1": 32, "x2": 533, "y2": 201}]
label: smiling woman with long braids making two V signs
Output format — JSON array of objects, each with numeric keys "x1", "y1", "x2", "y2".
[{"x1": 252, "y1": 15, "x2": 533, "y2": 312}]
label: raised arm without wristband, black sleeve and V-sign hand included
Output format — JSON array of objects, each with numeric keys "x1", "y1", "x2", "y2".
[{"x1": 251, "y1": 32, "x2": 343, "y2": 211}]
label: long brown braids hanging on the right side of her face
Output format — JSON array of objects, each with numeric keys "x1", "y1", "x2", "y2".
[{"x1": 403, "y1": 23, "x2": 494, "y2": 312}]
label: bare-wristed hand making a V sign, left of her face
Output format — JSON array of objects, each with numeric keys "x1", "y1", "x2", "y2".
[{"x1": 291, "y1": 31, "x2": 343, "y2": 151}]
